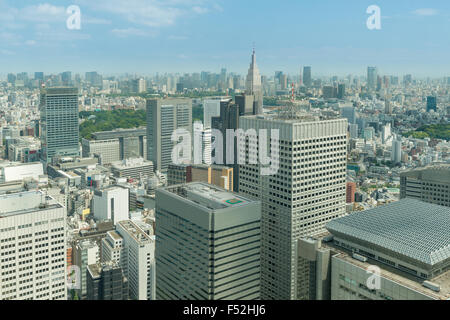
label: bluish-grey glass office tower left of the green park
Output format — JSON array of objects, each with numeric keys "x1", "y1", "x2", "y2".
[{"x1": 40, "y1": 88, "x2": 80, "y2": 164}]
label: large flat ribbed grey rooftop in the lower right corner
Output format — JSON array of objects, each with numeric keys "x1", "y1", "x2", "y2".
[{"x1": 326, "y1": 199, "x2": 450, "y2": 265}]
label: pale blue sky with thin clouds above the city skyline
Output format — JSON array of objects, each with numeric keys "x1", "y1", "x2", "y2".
[{"x1": 0, "y1": 0, "x2": 450, "y2": 77}]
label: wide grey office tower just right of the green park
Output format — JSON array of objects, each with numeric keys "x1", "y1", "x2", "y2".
[{"x1": 147, "y1": 99, "x2": 192, "y2": 171}]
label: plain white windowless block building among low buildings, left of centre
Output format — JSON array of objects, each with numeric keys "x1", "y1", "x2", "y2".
[{"x1": 93, "y1": 186, "x2": 130, "y2": 225}]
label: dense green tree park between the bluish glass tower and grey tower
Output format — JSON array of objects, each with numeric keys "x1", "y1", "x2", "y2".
[{"x1": 80, "y1": 110, "x2": 146, "y2": 139}]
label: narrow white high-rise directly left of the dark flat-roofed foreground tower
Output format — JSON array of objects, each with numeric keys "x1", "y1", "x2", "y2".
[{"x1": 116, "y1": 220, "x2": 156, "y2": 300}]
